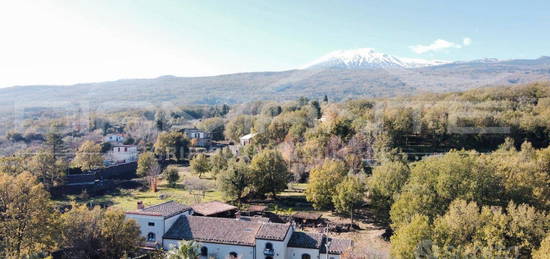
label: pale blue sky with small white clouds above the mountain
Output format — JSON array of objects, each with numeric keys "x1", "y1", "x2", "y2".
[{"x1": 0, "y1": 0, "x2": 550, "y2": 87}]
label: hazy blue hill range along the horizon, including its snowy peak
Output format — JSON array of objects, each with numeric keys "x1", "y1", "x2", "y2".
[{"x1": 0, "y1": 49, "x2": 550, "y2": 110}]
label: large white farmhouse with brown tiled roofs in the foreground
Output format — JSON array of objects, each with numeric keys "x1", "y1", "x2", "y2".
[{"x1": 126, "y1": 201, "x2": 352, "y2": 259}]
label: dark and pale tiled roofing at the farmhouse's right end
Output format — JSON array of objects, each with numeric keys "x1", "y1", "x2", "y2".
[{"x1": 288, "y1": 232, "x2": 353, "y2": 254}]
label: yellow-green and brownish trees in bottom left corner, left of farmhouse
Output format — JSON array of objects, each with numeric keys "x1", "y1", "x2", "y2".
[{"x1": 0, "y1": 172, "x2": 143, "y2": 258}]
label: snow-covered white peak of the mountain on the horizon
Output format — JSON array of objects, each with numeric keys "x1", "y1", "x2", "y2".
[{"x1": 304, "y1": 48, "x2": 450, "y2": 69}]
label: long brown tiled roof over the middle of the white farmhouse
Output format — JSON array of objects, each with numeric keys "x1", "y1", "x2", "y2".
[{"x1": 164, "y1": 216, "x2": 290, "y2": 246}]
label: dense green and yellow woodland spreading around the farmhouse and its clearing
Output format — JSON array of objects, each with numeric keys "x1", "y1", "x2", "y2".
[{"x1": 0, "y1": 83, "x2": 550, "y2": 258}]
